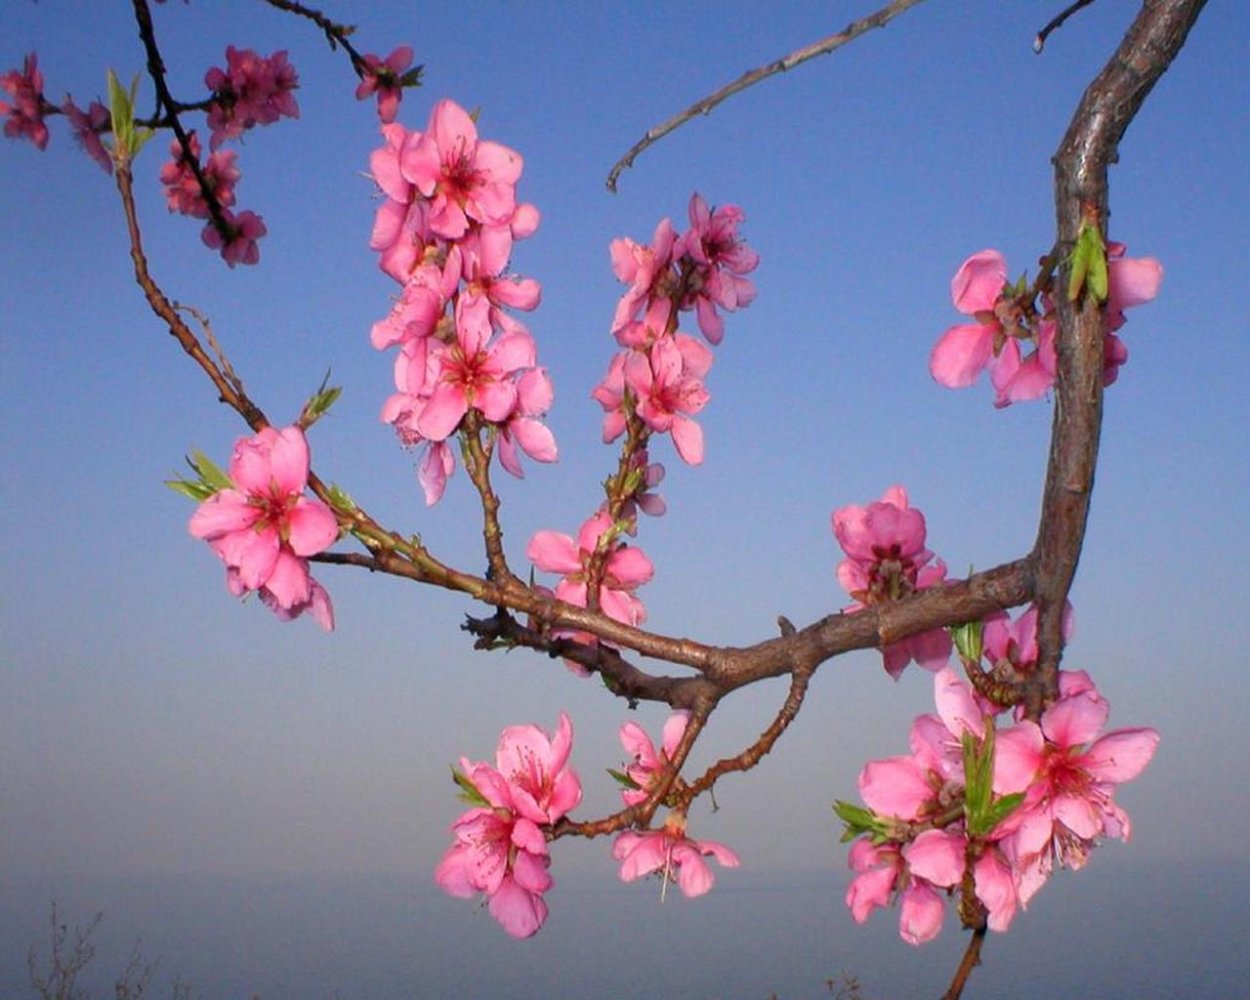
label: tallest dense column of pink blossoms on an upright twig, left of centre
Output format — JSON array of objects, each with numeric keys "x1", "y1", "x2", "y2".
[{"x1": 370, "y1": 100, "x2": 558, "y2": 504}]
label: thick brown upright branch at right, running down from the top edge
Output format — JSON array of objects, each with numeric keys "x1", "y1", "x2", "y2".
[{"x1": 1025, "y1": 0, "x2": 1205, "y2": 718}]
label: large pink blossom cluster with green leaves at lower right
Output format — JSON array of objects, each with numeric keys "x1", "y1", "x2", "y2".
[{"x1": 836, "y1": 625, "x2": 1159, "y2": 945}]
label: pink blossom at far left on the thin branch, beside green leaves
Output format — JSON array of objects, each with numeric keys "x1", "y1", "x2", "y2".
[{"x1": 188, "y1": 426, "x2": 339, "y2": 628}]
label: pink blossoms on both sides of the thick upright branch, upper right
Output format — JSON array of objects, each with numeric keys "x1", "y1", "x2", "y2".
[{"x1": 929, "y1": 243, "x2": 1163, "y2": 408}]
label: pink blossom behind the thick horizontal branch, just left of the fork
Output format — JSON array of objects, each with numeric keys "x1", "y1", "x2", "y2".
[{"x1": 833, "y1": 486, "x2": 951, "y2": 679}]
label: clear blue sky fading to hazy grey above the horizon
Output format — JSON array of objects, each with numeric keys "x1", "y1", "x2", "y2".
[{"x1": 0, "y1": 0, "x2": 1250, "y2": 980}]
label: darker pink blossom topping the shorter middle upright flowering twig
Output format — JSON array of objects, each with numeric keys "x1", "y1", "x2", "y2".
[{"x1": 679, "y1": 191, "x2": 760, "y2": 344}]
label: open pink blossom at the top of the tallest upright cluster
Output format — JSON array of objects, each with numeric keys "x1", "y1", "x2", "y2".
[{"x1": 400, "y1": 100, "x2": 523, "y2": 240}]
